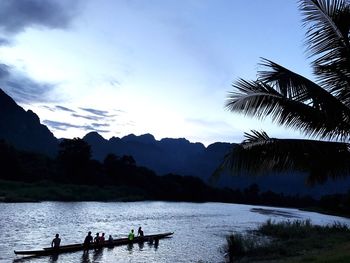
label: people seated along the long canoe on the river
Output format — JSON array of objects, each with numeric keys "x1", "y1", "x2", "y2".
[{"x1": 51, "y1": 227, "x2": 143, "y2": 250}]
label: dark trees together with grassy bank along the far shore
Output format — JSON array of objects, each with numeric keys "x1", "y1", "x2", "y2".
[{"x1": 0, "y1": 139, "x2": 350, "y2": 218}]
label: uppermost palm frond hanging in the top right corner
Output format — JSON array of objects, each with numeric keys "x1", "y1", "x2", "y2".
[{"x1": 300, "y1": 0, "x2": 350, "y2": 101}]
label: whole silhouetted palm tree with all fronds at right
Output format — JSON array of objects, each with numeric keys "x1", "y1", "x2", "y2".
[{"x1": 218, "y1": 0, "x2": 350, "y2": 185}]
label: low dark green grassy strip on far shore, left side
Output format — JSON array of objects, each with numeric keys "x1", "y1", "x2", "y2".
[{"x1": 0, "y1": 181, "x2": 147, "y2": 202}]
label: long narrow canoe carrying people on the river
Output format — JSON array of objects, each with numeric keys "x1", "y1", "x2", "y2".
[{"x1": 14, "y1": 232, "x2": 174, "y2": 256}]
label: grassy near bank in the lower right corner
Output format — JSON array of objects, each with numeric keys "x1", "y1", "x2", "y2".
[{"x1": 226, "y1": 221, "x2": 350, "y2": 262}]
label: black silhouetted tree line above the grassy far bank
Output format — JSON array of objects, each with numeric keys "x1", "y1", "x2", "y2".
[{"x1": 0, "y1": 138, "x2": 350, "y2": 214}]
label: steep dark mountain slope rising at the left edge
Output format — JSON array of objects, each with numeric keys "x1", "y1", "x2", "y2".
[{"x1": 0, "y1": 89, "x2": 57, "y2": 156}]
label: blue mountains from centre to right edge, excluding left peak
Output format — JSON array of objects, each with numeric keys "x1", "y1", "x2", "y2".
[{"x1": 83, "y1": 132, "x2": 350, "y2": 197}]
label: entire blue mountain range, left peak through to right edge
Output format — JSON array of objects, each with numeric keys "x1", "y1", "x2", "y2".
[{"x1": 0, "y1": 89, "x2": 350, "y2": 197}]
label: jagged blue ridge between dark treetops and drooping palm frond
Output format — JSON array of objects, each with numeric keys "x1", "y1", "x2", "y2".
[{"x1": 83, "y1": 132, "x2": 234, "y2": 180}]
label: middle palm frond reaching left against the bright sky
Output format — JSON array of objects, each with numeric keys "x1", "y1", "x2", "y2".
[{"x1": 226, "y1": 78, "x2": 350, "y2": 139}]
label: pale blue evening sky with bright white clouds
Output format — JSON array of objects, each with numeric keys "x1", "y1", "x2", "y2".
[{"x1": 0, "y1": 0, "x2": 312, "y2": 145}]
